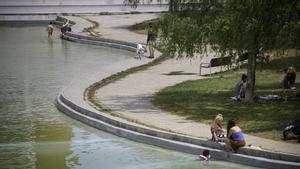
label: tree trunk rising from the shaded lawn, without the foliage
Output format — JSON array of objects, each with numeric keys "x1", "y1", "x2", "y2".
[{"x1": 245, "y1": 52, "x2": 257, "y2": 102}]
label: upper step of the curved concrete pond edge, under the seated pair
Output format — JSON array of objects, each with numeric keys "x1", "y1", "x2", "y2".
[{"x1": 60, "y1": 86, "x2": 299, "y2": 162}]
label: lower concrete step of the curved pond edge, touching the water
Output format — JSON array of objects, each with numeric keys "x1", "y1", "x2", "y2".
[{"x1": 56, "y1": 93, "x2": 300, "y2": 169}]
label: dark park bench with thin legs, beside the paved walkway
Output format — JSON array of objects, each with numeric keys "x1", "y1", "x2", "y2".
[{"x1": 199, "y1": 56, "x2": 231, "y2": 76}]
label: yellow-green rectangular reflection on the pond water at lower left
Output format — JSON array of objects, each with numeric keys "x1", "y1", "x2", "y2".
[{"x1": 32, "y1": 109, "x2": 73, "y2": 168}]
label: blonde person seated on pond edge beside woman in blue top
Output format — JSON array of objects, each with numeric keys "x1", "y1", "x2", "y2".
[{"x1": 210, "y1": 114, "x2": 225, "y2": 142}]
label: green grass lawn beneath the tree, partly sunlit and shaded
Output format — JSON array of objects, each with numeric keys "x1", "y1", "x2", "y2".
[{"x1": 153, "y1": 54, "x2": 300, "y2": 142}]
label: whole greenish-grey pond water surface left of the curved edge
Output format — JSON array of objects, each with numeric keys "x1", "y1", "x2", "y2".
[{"x1": 0, "y1": 26, "x2": 258, "y2": 169}]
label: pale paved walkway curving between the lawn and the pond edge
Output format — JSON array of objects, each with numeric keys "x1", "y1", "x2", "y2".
[{"x1": 63, "y1": 14, "x2": 300, "y2": 155}]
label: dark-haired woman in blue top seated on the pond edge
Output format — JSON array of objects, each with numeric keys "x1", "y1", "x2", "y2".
[{"x1": 225, "y1": 120, "x2": 246, "y2": 152}]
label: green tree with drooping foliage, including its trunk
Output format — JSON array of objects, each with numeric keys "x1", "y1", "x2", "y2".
[{"x1": 159, "y1": 0, "x2": 300, "y2": 102}]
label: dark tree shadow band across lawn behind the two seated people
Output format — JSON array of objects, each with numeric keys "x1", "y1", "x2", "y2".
[{"x1": 155, "y1": 91, "x2": 300, "y2": 132}]
